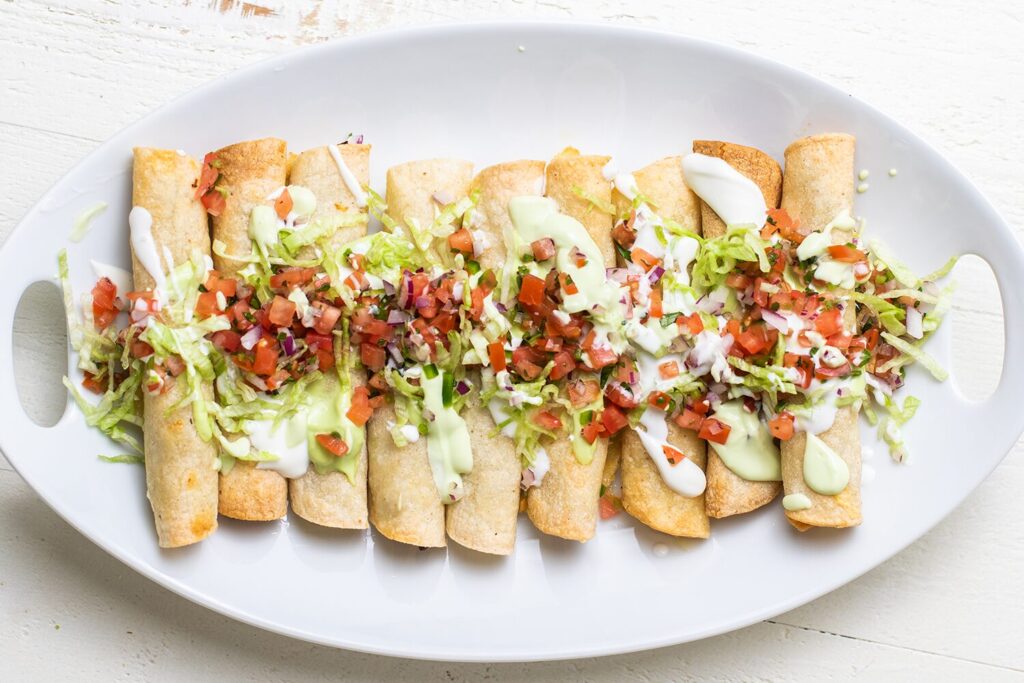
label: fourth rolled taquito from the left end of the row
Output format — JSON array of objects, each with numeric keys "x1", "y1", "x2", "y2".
[{"x1": 367, "y1": 159, "x2": 473, "y2": 548}]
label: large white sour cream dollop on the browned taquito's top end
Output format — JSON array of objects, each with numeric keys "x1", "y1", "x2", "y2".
[{"x1": 682, "y1": 154, "x2": 768, "y2": 227}]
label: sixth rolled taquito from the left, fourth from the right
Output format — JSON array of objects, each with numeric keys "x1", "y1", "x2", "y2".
[{"x1": 526, "y1": 150, "x2": 615, "y2": 542}]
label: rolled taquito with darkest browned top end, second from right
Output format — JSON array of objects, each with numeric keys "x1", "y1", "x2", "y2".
[{"x1": 693, "y1": 140, "x2": 782, "y2": 519}]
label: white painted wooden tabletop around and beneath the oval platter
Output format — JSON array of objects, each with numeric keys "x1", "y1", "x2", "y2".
[{"x1": 0, "y1": 0, "x2": 1024, "y2": 681}]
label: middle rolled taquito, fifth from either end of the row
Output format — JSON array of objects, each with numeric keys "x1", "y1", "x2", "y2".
[{"x1": 445, "y1": 160, "x2": 544, "y2": 555}]
